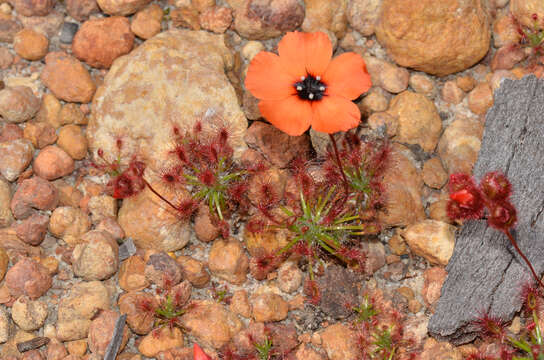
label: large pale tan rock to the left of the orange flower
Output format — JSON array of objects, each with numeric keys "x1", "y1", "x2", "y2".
[{"x1": 87, "y1": 30, "x2": 247, "y2": 176}]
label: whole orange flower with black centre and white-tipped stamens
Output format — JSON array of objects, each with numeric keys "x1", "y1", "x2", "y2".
[{"x1": 245, "y1": 32, "x2": 371, "y2": 136}]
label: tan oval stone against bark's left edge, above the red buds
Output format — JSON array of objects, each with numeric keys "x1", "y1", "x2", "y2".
[{"x1": 438, "y1": 117, "x2": 483, "y2": 174}]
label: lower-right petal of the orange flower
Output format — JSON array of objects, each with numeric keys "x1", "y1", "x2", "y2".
[{"x1": 312, "y1": 95, "x2": 361, "y2": 134}]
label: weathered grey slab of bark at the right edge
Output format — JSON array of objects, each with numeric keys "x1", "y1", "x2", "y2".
[{"x1": 429, "y1": 76, "x2": 544, "y2": 344}]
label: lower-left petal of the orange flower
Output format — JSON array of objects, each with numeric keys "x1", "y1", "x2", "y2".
[{"x1": 259, "y1": 95, "x2": 312, "y2": 136}]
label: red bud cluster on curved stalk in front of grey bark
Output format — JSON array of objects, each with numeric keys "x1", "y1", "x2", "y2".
[{"x1": 447, "y1": 171, "x2": 544, "y2": 288}]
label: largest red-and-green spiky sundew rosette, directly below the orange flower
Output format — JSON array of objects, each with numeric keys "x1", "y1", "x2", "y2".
[{"x1": 246, "y1": 134, "x2": 389, "y2": 305}]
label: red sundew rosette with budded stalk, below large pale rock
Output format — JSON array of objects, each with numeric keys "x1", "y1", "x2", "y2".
[{"x1": 93, "y1": 120, "x2": 247, "y2": 237}]
